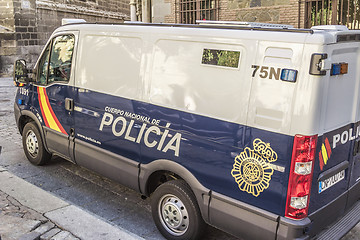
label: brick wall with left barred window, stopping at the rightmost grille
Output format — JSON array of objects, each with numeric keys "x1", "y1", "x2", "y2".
[{"x1": 152, "y1": 0, "x2": 305, "y2": 27}]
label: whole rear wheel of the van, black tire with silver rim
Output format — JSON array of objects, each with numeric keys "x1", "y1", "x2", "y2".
[{"x1": 151, "y1": 180, "x2": 206, "y2": 240}]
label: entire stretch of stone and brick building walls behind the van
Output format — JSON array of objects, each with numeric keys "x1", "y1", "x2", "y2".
[{"x1": 0, "y1": 0, "x2": 360, "y2": 76}]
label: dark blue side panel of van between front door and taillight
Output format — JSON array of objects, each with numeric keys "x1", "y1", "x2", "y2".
[{"x1": 74, "y1": 85, "x2": 293, "y2": 215}]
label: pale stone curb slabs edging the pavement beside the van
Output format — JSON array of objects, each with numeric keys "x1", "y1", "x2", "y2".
[{"x1": 0, "y1": 167, "x2": 143, "y2": 240}]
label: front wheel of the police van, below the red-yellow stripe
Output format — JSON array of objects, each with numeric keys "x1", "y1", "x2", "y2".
[{"x1": 22, "y1": 122, "x2": 51, "y2": 166}]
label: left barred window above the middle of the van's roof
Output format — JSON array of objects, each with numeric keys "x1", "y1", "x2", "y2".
[{"x1": 178, "y1": 0, "x2": 219, "y2": 24}]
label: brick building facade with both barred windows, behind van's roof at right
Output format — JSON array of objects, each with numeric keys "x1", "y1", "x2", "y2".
[{"x1": 152, "y1": 0, "x2": 360, "y2": 29}]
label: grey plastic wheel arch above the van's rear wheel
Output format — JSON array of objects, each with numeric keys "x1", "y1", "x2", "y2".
[{"x1": 139, "y1": 159, "x2": 211, "y2": 222}]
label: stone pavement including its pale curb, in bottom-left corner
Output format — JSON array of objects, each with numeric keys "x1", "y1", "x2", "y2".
[{"x1": 0, "y1": 167, "x2": 142, "y2": 240}]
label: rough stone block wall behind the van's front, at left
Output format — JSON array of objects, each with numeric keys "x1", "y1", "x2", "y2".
[{"x1": 0, "y1": 0, "x2": 130, "y2": 76}]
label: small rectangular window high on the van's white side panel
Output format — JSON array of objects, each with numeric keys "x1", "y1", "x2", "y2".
[{"x1": 201, "y1": 48, "x2": 240, "y2": 68}]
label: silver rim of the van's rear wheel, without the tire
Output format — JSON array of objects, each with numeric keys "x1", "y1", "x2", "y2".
[{"x1": 158, "y1": 194, "x2": 189, "y2": 236}]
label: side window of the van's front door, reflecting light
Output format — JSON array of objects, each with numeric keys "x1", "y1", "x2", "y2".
[{"x1": 48, "y1": 35, "x2": 75, "y2": 84}]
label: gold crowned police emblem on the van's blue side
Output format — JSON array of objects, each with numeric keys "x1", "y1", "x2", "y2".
[{"x1": 231, "y1": 138, "x2": 278, "y2": 197}]
